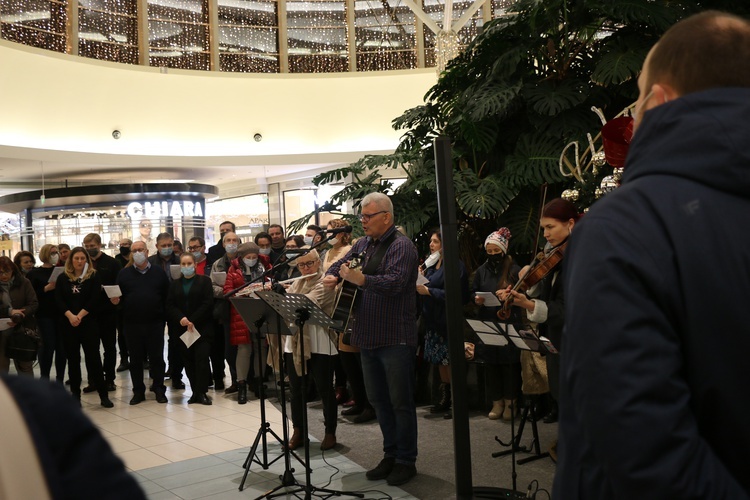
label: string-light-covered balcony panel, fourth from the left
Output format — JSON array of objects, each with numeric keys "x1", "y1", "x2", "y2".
[{"x1": 218, "y1": 0, "x2": 279, "y2": 73}]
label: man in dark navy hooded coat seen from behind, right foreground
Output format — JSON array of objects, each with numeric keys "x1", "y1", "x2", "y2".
[{"x1": 554, "y1": 12, "x2": 750, "y2": 499}]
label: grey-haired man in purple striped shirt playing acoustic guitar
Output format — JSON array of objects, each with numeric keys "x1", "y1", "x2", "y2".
[{"x1": 323, "y1": 193, "x2": 419, "y2": 486}]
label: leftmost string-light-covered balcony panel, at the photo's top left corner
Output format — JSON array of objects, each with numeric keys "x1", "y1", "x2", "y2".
[{"x1": 0, "y1": 0, "x2": 68, "y2": 52}]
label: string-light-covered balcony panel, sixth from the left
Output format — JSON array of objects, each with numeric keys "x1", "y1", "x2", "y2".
[{"x1": 354, "y1": 0, "x2": 417, "y2": 71}]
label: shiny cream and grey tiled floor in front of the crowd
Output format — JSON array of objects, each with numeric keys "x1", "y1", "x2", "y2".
[{"x1": 82, "y1": 372, "x2": 414, "y2": 500}]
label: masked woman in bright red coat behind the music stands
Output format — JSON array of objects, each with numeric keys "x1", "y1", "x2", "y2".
[{"x1": 224, "y1": 242, "x2": 270, "y2": 405}]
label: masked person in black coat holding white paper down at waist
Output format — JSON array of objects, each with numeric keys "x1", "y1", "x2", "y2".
[{"x1": 167, "y1": 253, "x2": 214, "y2": 405}]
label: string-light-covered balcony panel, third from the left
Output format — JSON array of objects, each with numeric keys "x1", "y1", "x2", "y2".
[{"x1": 148, "y1": 0, "x2": 211, "y2": 70}]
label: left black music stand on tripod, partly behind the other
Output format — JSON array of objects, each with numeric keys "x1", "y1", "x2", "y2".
[{"x1": 229, "y1": 296, "x2": 307, "y2": 498}]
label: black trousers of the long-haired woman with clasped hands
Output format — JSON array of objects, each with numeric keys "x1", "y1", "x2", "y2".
[{"x1": 60, "y1": 315, "x2": 106, "y2": 394}]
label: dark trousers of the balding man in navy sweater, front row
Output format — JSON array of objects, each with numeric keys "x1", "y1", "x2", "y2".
[{"x1": 125, "y1": 321, "x2": 165, "y2": 395}]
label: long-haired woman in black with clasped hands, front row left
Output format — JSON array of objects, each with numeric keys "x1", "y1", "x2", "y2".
[{"x1": 55, "y1": 247, "x2": 114, "y2": 408}]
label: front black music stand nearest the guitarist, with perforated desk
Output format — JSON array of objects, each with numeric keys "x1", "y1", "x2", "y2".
[{"x1": 256, "y1": 291, "x2": 364, "y2": 500}]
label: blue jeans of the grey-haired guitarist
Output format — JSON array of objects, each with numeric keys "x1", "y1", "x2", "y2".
[{"x1": 361, "y1": 345, "x2": 417, "y2": 464}]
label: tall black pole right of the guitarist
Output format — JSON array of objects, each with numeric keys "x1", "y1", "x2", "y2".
[{"x1": 433, "y1": 137, "x2": 473, "y2": 500}]
